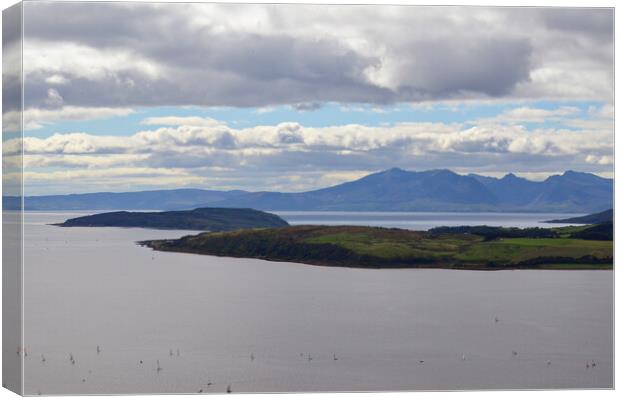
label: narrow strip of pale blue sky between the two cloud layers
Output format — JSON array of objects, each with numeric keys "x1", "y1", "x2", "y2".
[{"x1": 19, "y1": 101, "x2": 604, "y2": 140}]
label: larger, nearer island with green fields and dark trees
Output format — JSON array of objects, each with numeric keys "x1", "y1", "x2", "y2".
[{"x1": 139, "y1": 226, "x2": 613, "y2": 270}]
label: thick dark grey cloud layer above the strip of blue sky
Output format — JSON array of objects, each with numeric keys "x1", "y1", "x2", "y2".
[{"x1": 17, "y1": 2, "x2": 613, "y2": 110}]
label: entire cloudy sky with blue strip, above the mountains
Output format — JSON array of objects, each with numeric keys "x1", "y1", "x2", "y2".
[{"x1": 3, "y1": 2, "x2": 614, "y2": 195}]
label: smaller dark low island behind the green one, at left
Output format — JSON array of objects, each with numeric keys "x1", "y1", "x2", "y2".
[{"x1": 56, "y1": 208, "x2": 288, "y2": 232}]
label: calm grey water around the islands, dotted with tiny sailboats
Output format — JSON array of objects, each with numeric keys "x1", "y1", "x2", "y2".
[{"x1": 25, "y1": 213, "x2": 613, "y2": 394}]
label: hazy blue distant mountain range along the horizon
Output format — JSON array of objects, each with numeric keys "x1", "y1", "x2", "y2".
[{"x1": 3, "y1": 168, "x2": 613, "y2": 213}]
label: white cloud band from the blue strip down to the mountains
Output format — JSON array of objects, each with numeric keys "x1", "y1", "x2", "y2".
[{"x1": 12, "y1": 116, "x2": 613, "y2": 190}]
